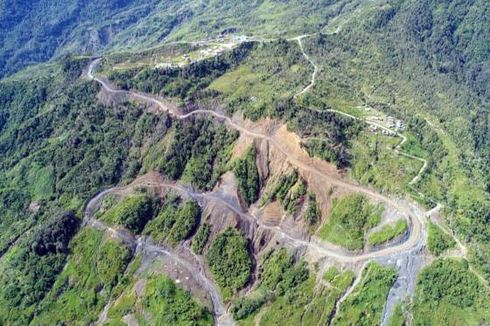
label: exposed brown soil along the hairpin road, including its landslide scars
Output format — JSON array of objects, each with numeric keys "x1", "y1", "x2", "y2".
[{"x1": 83, "y1": 57, "x2": 448, "y2": 324}]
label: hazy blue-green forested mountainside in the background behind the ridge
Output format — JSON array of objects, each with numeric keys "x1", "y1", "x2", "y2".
[{"x1": 0, "y1": 0, "x2": 342, "y2": 76}]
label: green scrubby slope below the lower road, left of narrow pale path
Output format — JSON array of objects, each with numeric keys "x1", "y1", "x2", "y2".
[{"x1": 232, "y1": 248, "x2": 354, "y2": 325}]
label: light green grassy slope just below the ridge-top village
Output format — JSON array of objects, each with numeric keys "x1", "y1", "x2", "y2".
[{"x1": 209, "y1": 40, "x2": 313, "y2": 120}]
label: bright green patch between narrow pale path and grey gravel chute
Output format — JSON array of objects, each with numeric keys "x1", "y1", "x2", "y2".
[{"x1": 333, "y1": 263, "x2": 396, "y2": 325}]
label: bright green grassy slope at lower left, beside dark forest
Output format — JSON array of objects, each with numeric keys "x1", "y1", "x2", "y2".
[{"x1": 32, "y1": 228, "x2": 131, "y2": 325}]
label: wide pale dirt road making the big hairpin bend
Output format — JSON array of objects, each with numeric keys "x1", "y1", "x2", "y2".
[{"x1": 87, "y1": 57, "x2": 448, "y2": 324}]
